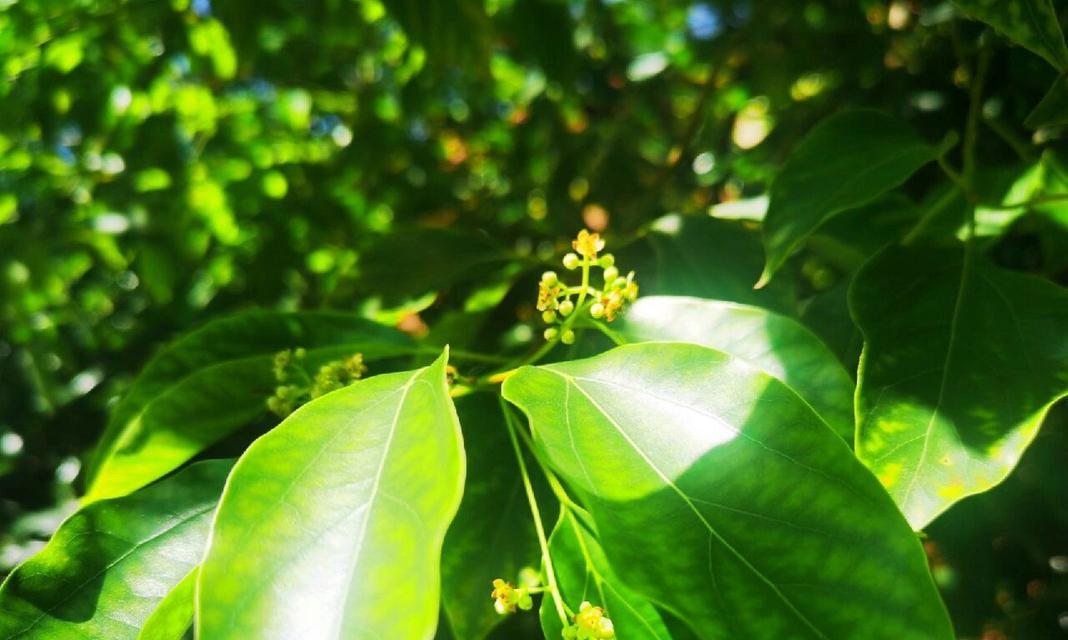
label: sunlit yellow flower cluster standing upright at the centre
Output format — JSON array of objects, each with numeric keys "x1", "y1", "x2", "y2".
[{"x1": 537, "y1": 229, "x2": 638, "y2": 344}]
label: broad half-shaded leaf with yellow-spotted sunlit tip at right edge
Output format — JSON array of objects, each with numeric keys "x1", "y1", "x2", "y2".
[{"x1": 849, "y1": 246, "x2": 1068, "y2": 529}]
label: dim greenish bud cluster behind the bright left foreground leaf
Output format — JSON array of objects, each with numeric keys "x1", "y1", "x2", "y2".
[{"x1": 267, "y1": 347, "x2": 367, "y2": 418}]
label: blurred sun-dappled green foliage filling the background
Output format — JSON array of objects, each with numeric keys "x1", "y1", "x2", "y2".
[{"x1": 0, "y1": 0, "x2": 1068, "y2": 640}]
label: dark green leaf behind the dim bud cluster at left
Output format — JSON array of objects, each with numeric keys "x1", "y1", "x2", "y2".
[{"x1": 85, "y1": 312, "x2": 413, "y2": 502}]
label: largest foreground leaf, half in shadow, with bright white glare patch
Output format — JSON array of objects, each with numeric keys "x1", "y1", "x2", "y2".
[{"x1": 504, "y1": 343, "x2": 953, "y2": 640}]
